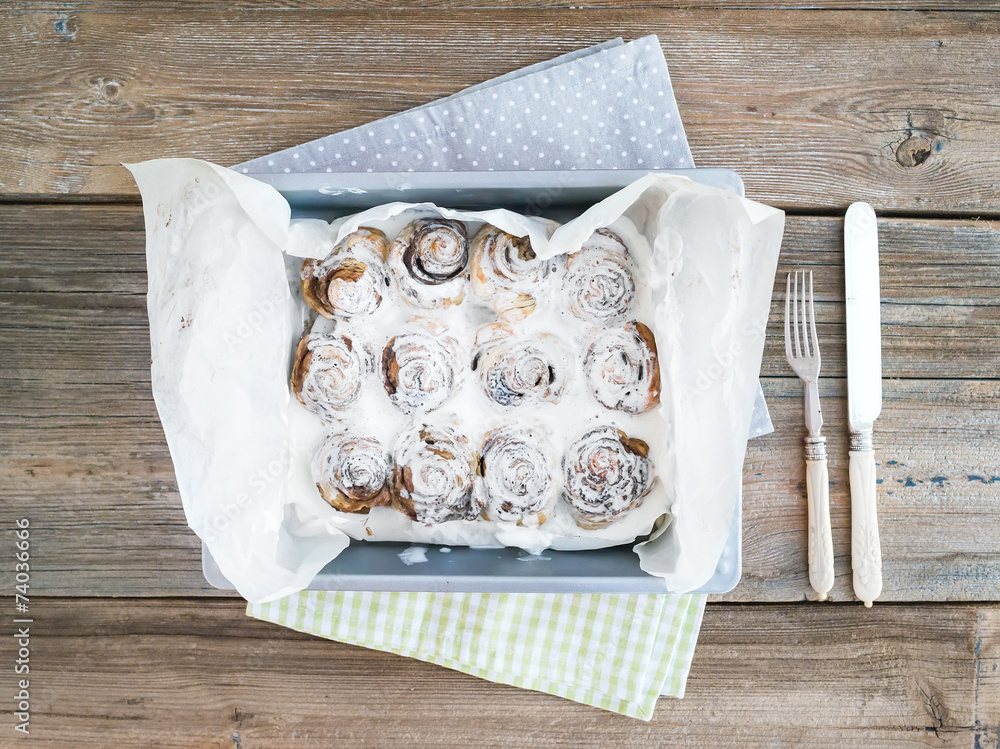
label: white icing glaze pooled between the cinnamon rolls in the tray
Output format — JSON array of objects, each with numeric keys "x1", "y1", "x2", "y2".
[{"x1": 293, "y1": 211, "x2": 669, "y2": 553}]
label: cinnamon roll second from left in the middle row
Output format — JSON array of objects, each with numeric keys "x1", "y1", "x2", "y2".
[{"x1": 382, "y1": 321, "x2": 460, "y2": 414}]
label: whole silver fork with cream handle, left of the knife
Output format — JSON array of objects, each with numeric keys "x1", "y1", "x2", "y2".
[{"x1": 785, "y1": 271, "x2": 833, "y2": 601}]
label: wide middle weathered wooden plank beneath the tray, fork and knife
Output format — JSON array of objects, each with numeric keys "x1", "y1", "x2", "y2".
[{"x1": 0, "y1": 205, "x2": 1000, "y2": 601}]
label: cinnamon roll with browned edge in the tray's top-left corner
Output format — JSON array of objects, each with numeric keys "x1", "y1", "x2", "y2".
[{"x1": 301, "y1": 227, "x2": 389, "y2": 319}]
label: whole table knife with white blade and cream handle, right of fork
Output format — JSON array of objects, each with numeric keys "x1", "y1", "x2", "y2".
[{"x1": 844, "y1": 203, "x2": 882, "y2": 606}]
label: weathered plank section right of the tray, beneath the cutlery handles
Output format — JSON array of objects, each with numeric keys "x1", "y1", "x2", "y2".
[{"x1": 740, "y1": 379, "x2": 1000, "y2": 601}]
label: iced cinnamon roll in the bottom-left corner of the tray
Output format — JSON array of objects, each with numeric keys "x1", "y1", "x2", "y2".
[{"x1": 312, "y1": 432, "x2": 392, "y2": 512}]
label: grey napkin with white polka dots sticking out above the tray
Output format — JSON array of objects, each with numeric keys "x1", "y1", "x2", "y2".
[{"x1": 235, "y1": 36, "x2": 692, "y2": 174}]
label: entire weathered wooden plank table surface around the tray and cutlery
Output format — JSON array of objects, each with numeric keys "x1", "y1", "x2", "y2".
[{"x1": 0, "y1": 0, "x2": 1000, "y2": 749}]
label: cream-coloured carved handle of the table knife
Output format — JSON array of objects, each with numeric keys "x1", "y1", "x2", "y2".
[{"x1": 851, "y1": 450, "x2": 882, "y2": 606}]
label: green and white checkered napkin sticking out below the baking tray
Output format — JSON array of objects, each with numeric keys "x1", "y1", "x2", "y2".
[{"x1": 247, "y1": 591, "x2": 706, "y2": 720}]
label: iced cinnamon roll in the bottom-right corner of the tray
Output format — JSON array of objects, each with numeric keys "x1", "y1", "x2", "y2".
[{"x1": 562, "y1": 426, "x2": 652, "y2": 529}]
